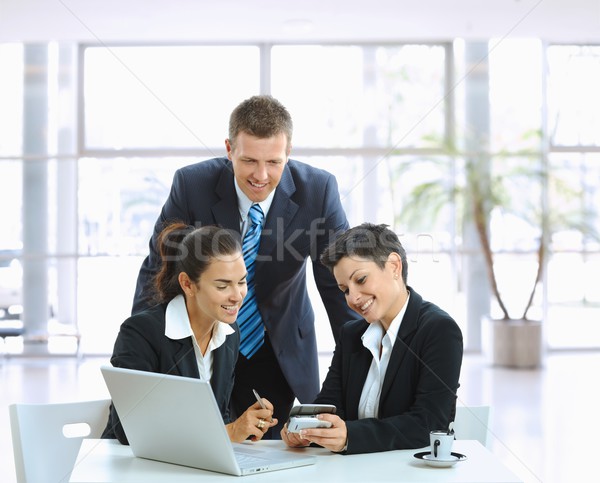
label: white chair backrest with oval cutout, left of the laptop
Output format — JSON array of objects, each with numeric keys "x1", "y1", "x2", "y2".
[{"x1": 9, "y1": 399, "x2": 110, "y2": 483}]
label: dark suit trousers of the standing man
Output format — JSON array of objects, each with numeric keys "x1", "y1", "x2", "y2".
[{"x1": 231, "y1": 332, "x2": 295, "y2": 439}]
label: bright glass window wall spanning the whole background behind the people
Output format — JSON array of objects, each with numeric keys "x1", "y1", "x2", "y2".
[{"x1": 0, "y1": 39, "x2": 600, "y2": 353}]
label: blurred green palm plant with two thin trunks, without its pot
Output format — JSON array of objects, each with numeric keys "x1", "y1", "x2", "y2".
[{"x1": 392, "y1": 136, "x2": 598, "y2": 320}]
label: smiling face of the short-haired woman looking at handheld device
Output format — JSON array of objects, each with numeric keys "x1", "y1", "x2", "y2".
[{"x1": 333, "y1": 253, "x2": 404, "y2": 329}]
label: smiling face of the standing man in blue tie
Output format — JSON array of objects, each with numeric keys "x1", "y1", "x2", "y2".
[{"x1": 225, "y1": 132, "x2": 289, "y2": 203}]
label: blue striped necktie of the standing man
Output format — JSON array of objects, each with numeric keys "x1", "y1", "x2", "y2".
[{"x1": 237, "y1": 204, "x2": 265, "y2": 359}]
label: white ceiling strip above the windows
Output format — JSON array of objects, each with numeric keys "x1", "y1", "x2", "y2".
[{"x1": 0, "y1": 0, "x2": 600, "y2": 42}]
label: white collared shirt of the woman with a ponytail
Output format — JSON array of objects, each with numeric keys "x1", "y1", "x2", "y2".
[{"x1": 165, "y1": 295, "x2": 235, "y2": 381}]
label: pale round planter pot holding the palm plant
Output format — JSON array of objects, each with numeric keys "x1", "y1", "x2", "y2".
[{"x1": 491, "y1": 319, "x2": 542, "y2": 368}]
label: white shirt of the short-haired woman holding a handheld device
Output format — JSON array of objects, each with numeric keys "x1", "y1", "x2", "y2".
[{"x1": 358, "y1": 294, "x2": 410, "y2": 419}]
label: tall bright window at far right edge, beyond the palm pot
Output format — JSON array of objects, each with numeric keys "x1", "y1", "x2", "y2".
[{"x1": 547, "y1": 45, "x2": 600, "y2": 348}]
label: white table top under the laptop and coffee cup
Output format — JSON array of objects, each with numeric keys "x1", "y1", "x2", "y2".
[{"x1": 70, "y1": 439, "x2": 523, "y2": 483}]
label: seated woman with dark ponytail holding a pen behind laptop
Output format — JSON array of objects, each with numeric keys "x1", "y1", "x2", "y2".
[{"x1": 102, "y1": 223, "x2": 277, "y2": 444}]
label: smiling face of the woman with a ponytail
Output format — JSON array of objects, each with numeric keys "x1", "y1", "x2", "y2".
[{"x1": 187, "y1": 253, "x2": 248, "y2": 324}]
